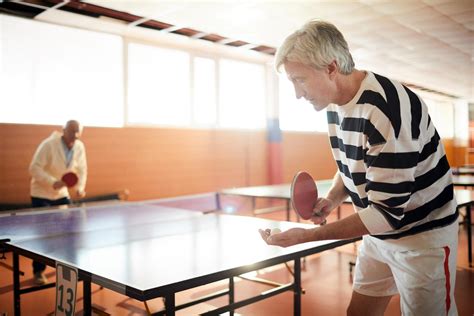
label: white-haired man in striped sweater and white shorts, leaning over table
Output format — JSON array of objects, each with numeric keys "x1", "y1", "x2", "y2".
[{"x1": 260, "y1": 21, "x2": 459, "y2": 316}]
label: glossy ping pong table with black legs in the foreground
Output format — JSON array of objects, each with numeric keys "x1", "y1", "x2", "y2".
[{"x1": 0, "y1": 201, "x2": 353, "y2": 315}]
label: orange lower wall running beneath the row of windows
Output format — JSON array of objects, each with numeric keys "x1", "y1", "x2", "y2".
[{"x1": 0, "y1": 124, "x2": 465, "y2": 203}]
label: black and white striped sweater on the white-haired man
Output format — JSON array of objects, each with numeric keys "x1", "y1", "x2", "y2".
[{"x1": 327, "y1": 72, "x2": 458, "y2": 240}]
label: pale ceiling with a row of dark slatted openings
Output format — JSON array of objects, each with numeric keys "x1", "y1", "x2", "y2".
[{"x1": 0, "y1": 0, "x2": 474, "y2": 102}]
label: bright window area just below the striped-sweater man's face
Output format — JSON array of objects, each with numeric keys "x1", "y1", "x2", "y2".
[{"x1": 278, "y1": 74, "x2": 328, "y2": 132}]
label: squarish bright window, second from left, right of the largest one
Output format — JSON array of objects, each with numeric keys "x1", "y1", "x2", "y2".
[{"x1": 127, "y1": 43, "x2": 191, "y2": 126}]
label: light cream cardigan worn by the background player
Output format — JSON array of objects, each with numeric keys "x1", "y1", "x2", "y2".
[{"x1": 29, "y1": 131, "x2": 87, "y2": 200}]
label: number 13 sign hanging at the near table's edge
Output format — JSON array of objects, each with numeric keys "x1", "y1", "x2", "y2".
[{"x1": 54, "y1": 262, "x2": 77, "y2": 316}]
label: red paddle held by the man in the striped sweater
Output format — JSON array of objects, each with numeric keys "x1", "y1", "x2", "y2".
[{"x1": 291, "y1": 171, "x2": 326, "y2": 225}]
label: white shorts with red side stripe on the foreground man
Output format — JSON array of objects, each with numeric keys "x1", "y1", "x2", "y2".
[{"x1": 353, "y1": 236, "x2": 457, "y2": 316}]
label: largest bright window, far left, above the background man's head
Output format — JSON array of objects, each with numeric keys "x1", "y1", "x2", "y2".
[{"x1": 0, "y1": 15, "x2": 123, "y2": 126}]
